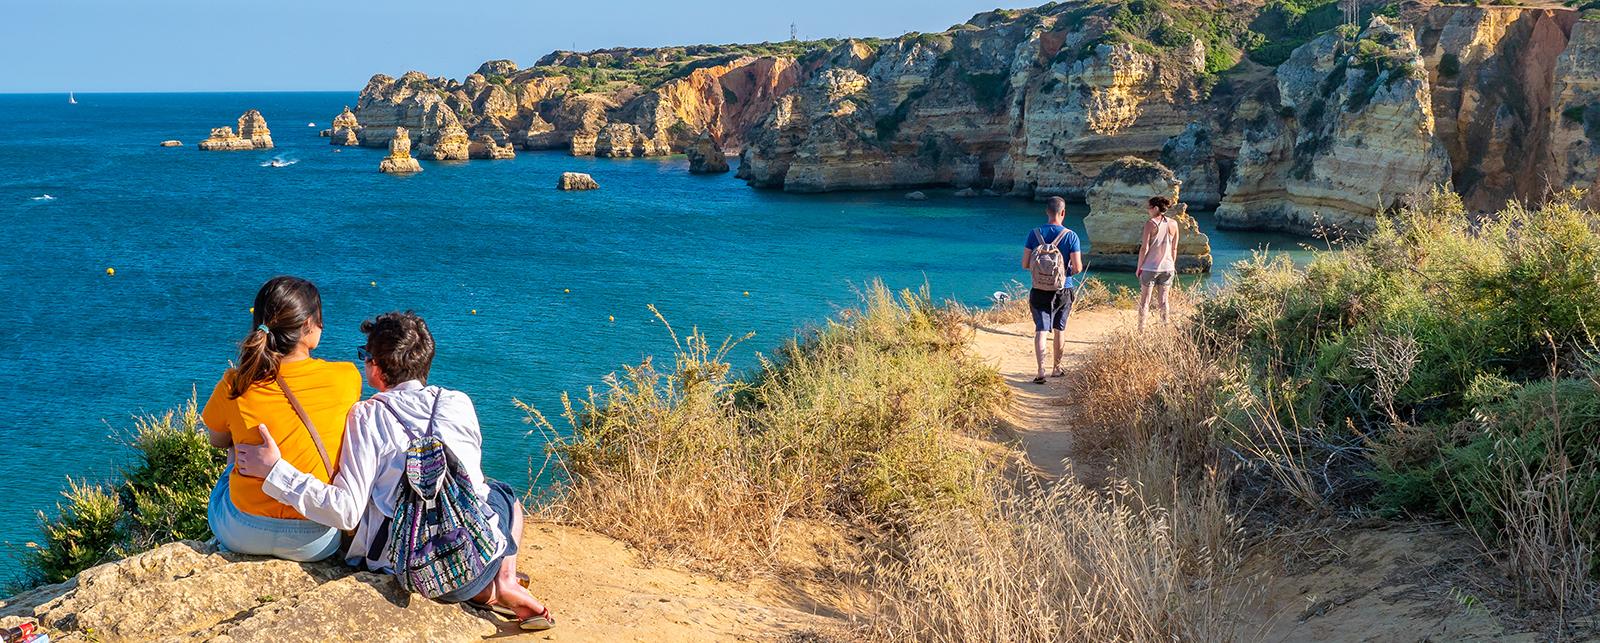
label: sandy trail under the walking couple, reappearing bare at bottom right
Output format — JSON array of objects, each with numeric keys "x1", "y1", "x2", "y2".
[{"x1": 973, "y1": 309, "x2": 1539, "y2": 641}]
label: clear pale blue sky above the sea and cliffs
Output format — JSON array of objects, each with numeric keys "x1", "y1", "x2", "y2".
[{"x1": 0, "y1": 0, "x2": 1038, "y2": 93}]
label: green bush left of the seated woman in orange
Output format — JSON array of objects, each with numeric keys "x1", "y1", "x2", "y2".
[{"x1": 13, "y1": 398, "x2": 226, "y2": 587}]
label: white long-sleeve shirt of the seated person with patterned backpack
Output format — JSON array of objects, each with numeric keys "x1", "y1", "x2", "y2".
[{"x1": 261, "y1": 379, "x2": 504, "y2": 571}]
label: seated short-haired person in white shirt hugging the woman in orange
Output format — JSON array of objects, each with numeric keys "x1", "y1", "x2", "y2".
[{"x1": 235, "y1": 312, "x2": 555, "y2": 630}]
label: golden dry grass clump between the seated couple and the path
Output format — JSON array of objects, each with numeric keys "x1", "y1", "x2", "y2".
[{"x1": 525, "y1": 285, "x2": 1008, "y2": 576}]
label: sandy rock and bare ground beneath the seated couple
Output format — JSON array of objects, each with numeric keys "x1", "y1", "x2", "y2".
[{"x1": 0, "y1": 523, "x2": 842, "y2": 643}]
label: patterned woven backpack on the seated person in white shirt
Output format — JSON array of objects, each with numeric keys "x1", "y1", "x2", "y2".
[{"x1": 373, "y1": 392, "x2": 506, "y2": 598}]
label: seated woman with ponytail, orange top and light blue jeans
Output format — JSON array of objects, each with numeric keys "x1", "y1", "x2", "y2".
[{"x1": 200, "y1": 277, "x2": 362, "y2": 561}]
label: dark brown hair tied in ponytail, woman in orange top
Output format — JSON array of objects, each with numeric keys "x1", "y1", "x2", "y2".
[{"x1": 227, "y1": 277, "x2": 322, "y2": 398}]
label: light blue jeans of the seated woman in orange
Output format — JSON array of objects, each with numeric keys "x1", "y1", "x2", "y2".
[{"x1": 206, "y1": 465, "x2": 339, "y2": 563}]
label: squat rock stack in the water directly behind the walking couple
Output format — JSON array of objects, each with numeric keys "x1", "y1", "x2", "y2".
[{"x1": 1083, "y1": 157, "x2": 1211, "y2": 272}]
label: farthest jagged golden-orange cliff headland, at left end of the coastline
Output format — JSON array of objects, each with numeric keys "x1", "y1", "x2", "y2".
[{"x1": 352, "y1": 50, "x2": 798, "y2": 160}]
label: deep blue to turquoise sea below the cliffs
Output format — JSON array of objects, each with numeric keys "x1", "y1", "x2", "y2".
[{"x1": 0, "y1": 93, "x2": 1299, "y2": 573}]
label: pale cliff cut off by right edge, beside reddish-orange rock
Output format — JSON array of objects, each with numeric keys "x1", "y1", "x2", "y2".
[{"x1": 1549, "y1": 19, "x2": 1600, "y2": 208}]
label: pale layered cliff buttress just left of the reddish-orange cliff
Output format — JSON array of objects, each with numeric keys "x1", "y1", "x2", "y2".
[{"x1": 1216, "y1": 18, "x2": 1450, "y2": 234}]
